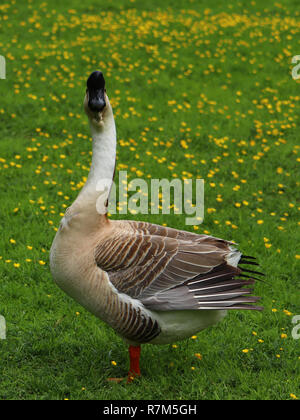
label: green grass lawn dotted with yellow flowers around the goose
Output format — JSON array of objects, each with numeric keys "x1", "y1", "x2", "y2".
[{"x1": 0, "y1": 0, "x2": 300, "y2": 400}]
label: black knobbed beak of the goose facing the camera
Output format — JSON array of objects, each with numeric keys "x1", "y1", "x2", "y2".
[{"x1": 87, "y1": 71, "x2": 106, "y2": 112}]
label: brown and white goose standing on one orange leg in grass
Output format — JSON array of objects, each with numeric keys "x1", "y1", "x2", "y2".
[{"x1": 50, "y1": 71, "x2": 263, "y2": 382}]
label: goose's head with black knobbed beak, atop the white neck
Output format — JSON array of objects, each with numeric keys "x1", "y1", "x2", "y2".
[{"x1": 84, "y1": 71, "x2": 110, "y2": 128}]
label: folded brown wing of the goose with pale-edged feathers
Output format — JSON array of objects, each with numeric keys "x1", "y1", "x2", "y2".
[{"x1": 95, "y1": 221, "x2": 261, "y2": 310}]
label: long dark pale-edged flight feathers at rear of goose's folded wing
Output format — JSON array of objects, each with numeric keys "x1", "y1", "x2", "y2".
[{"x1": 142, "y1": 248, "x2": 263, "y2": 311}]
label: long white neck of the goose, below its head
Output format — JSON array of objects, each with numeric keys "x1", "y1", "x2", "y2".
[{"x1": 74, "y1": 105, "x2": 117, "y2": 212}]
